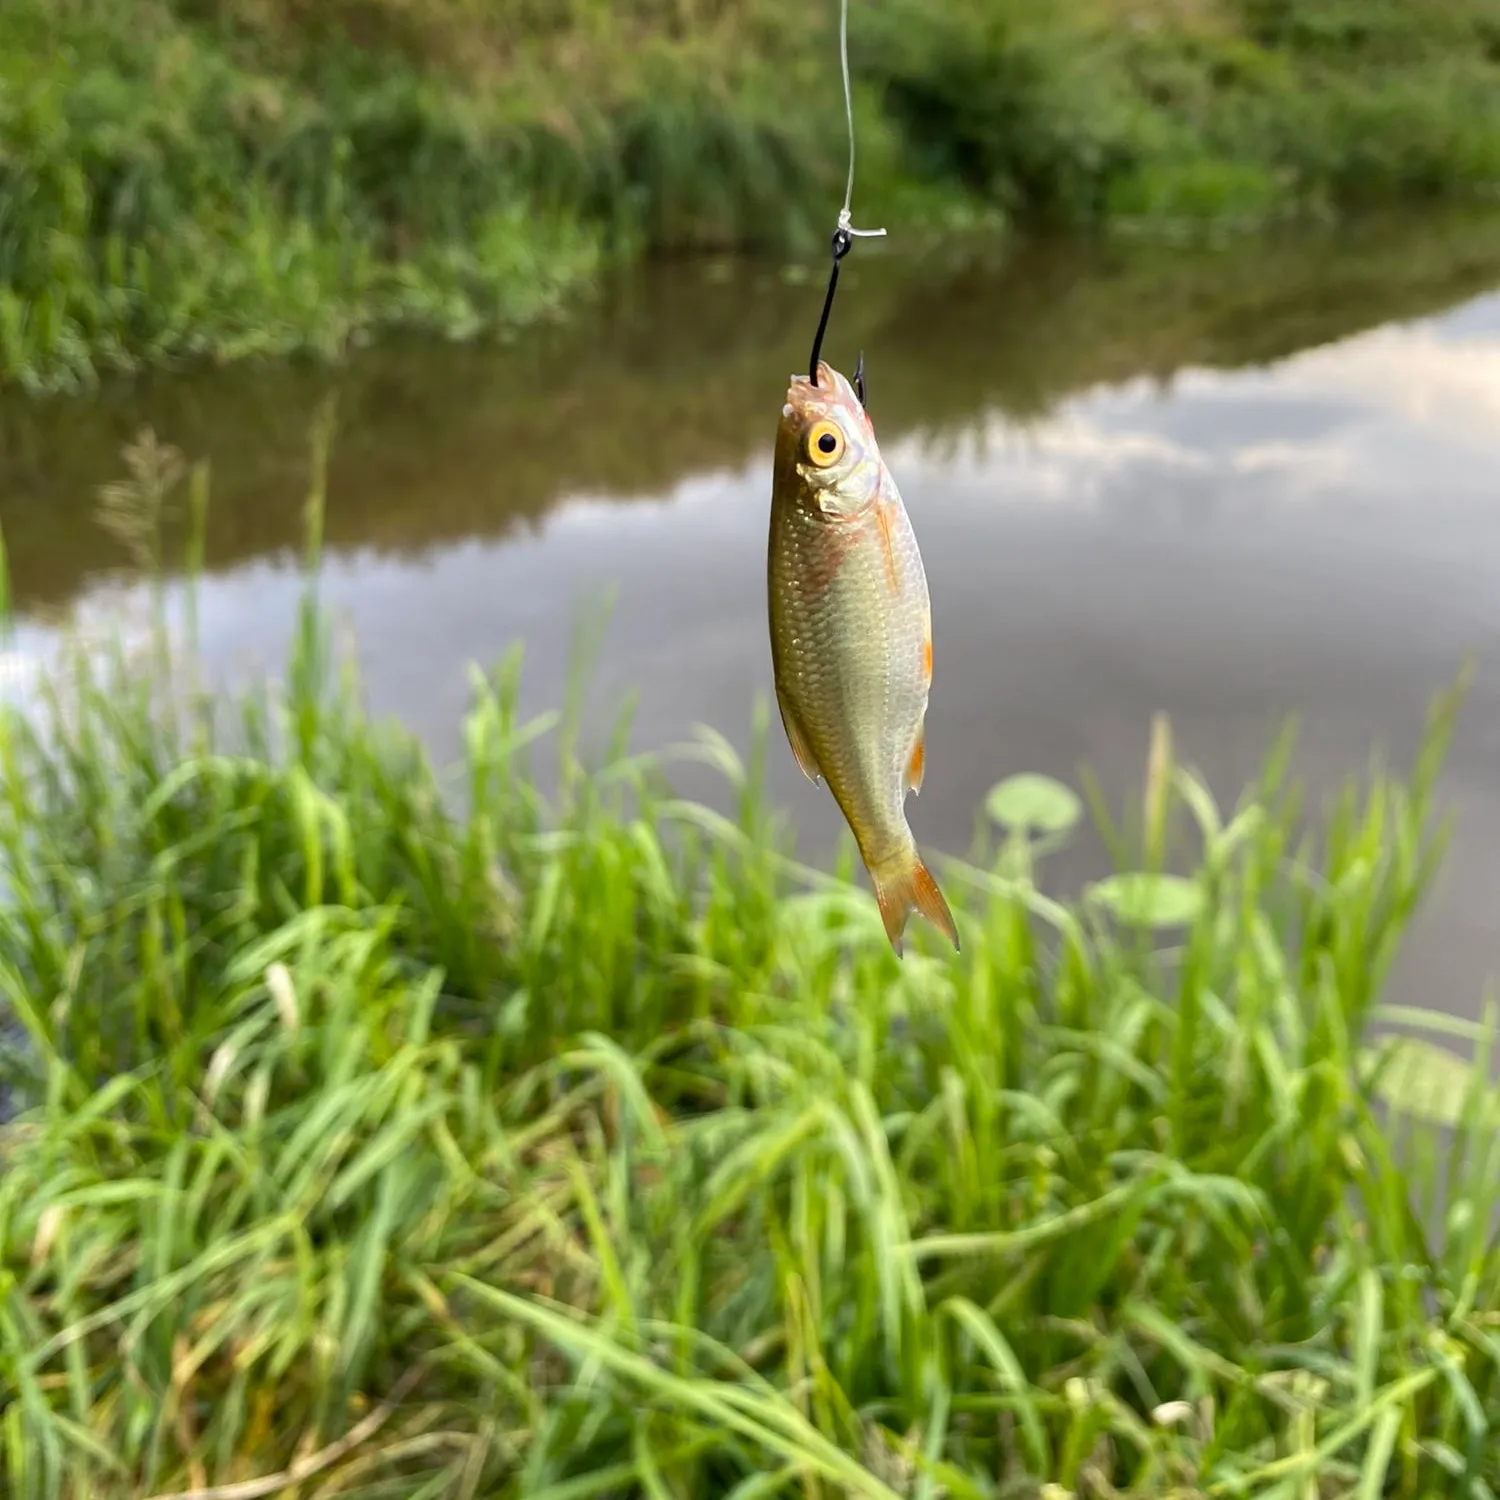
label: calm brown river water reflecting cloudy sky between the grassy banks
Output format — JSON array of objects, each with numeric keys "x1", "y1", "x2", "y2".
[{"x1": 0, "y1": 205, "x2": 1500, "y2": 1014}]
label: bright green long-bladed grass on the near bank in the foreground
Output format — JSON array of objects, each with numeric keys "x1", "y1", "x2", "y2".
[{"x1": 0, "y1": 432, "x2": 1500, "y2": 1500}]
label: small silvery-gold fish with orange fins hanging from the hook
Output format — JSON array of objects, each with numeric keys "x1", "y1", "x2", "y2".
[{"x1": 767, "y1": 360, "x2": 959, "y2": 956}]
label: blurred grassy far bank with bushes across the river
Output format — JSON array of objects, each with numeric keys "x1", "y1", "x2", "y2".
[{"x1": 0, "y1": 0, "x2": 1500, "y2": 386}]
